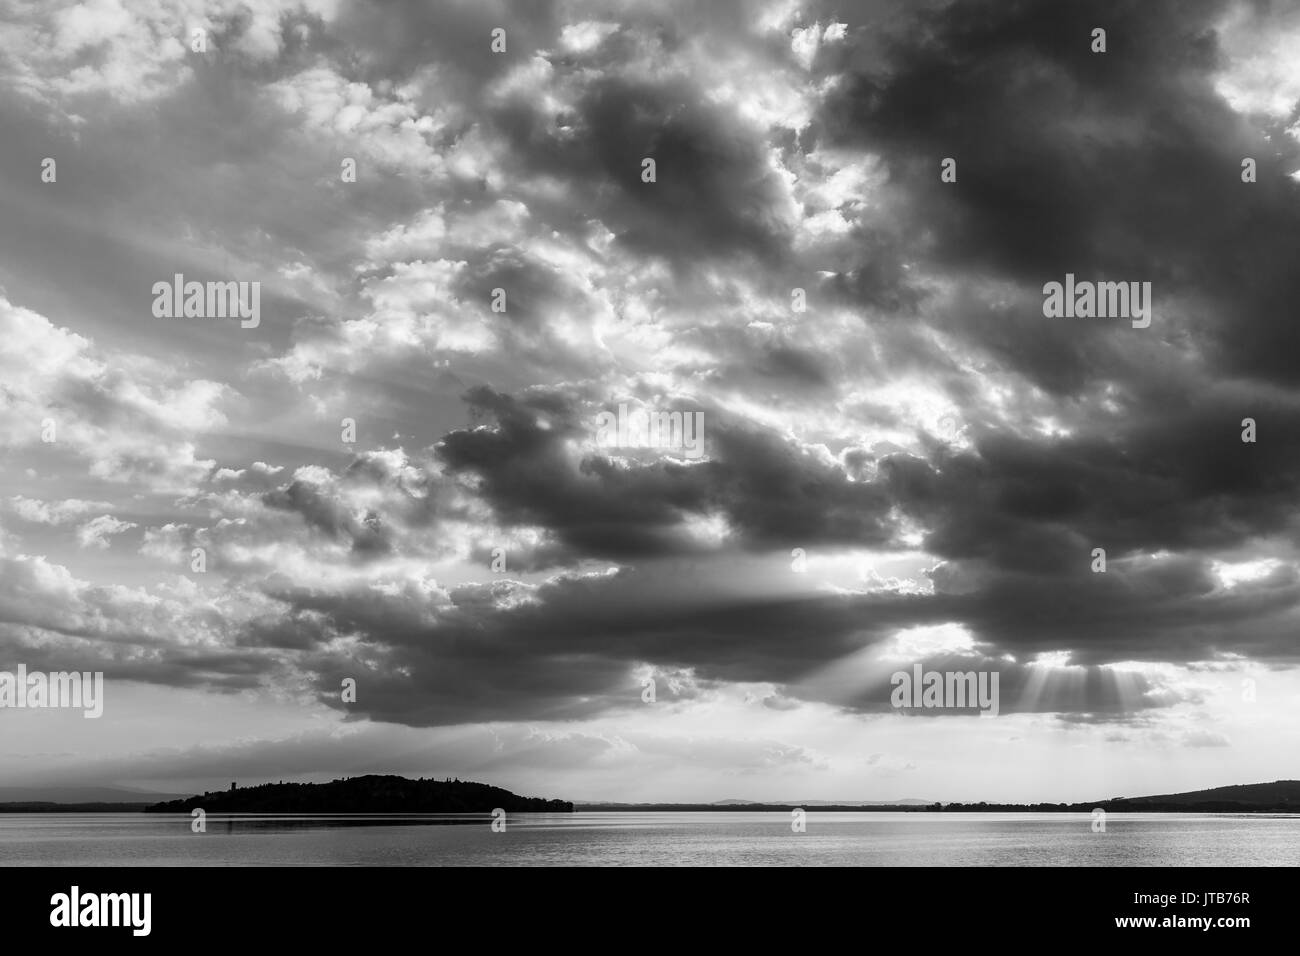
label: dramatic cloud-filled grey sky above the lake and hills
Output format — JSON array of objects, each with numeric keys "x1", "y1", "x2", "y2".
[{"x1": 0, "y1": 0, "x2": 1300, "y2": 803}]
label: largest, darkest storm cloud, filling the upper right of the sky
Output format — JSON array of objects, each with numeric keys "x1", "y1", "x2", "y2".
[{"x1": 814, "y1": 1, "x2": 1300, "y2": 389}]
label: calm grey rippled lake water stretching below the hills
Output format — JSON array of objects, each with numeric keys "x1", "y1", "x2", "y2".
[{"x1": 0, "y1": 812, "x2": 1300, "y2": 866}]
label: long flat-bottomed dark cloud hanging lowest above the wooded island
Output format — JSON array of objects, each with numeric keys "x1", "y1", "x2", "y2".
[{"x1": 263, "y1": 571, "x2": 939, "y2": 724}]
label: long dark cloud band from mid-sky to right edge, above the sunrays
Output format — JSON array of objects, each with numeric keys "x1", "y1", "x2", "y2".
[{"x1": 438, "y1": 377, "x2": 1300, "y2": 587}]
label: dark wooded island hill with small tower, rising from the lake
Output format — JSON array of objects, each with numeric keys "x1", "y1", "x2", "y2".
[{"x1": 146, "y1": 774, "x2": 573, "y2": 813}]
